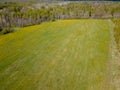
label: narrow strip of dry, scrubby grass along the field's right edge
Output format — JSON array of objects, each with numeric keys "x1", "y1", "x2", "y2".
[{"x1": 111, "y1": 19, "x2": 120, "y2": 90}]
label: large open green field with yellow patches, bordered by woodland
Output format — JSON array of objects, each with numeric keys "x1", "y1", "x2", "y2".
[{"x1": 0, "y1": 19, "x2": 113, "y2": 90}]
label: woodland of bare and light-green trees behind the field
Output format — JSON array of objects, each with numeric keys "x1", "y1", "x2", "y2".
[{"x1": 0, "y1": 2, "x2": 120, "y2": 34}]
